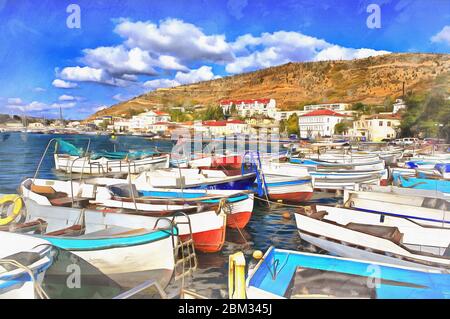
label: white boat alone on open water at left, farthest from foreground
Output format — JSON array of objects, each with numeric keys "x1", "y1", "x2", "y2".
[{"x1": 54, "y1": 154, "x2": 170, "y2": 175}]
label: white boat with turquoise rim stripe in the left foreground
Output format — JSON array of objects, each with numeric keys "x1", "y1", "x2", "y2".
[{"x1": 2, "y1": 198, "x2": 179, "y2": 288}]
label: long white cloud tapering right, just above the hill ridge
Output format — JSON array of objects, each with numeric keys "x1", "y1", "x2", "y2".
[{"x1": 225, "y1": 31, "x2": 389, "y2": 73}]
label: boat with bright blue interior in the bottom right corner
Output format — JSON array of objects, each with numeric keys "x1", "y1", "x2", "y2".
[{"x1": 246, "y1": 247, "x2": 450, "y2": 299}]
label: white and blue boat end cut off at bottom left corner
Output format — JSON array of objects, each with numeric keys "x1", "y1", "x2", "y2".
[{"x1": 0, "y1": 231, "x2": 53, "y2": 299}]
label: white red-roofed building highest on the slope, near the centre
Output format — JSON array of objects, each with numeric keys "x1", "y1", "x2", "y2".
[{"x1": 220, "y1": 99, "x2": 277, "y2": 117}]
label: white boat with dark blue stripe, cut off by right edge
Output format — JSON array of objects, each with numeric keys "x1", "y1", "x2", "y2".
[{"x1": 344, "y1": 191, "x2": 450, "y2": 228}]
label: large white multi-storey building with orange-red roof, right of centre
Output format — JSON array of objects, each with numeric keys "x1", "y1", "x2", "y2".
[{"x1": 298, "y1": 110, "x2": 349, "y2": 138}]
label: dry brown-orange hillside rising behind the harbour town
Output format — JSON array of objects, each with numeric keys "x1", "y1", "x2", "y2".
[{"x1": 88, "y1": 53, "x2": 450, "y2": 117}]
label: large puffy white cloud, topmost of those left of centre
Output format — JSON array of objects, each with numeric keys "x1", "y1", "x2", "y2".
[{"x1": 114, "y1": 19, "x2": 234, "y2": 62}]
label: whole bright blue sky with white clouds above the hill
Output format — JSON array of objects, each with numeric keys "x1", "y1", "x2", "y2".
[{"x1": 0, "y1": 0, "x2": 450, "y2": 119}]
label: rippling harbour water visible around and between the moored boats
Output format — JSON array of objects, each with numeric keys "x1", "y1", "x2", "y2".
[{"x1": 0, "y1": 133, "x2": 335, "y2": 298}]
